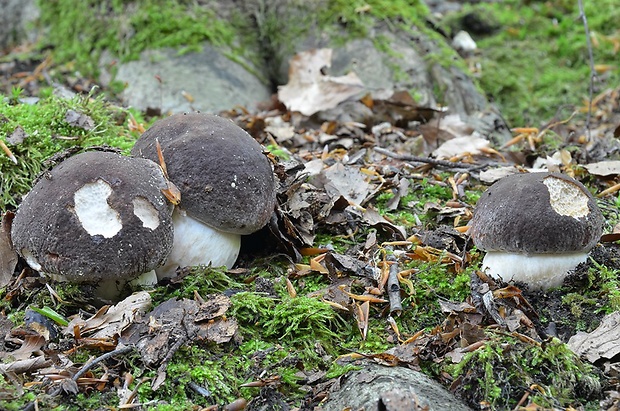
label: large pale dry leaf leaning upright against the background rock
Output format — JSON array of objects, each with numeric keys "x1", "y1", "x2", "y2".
[{"x1": 278, "y1": 49, "x2": 364, "y2": 116}]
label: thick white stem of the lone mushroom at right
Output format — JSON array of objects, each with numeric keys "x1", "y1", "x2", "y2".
[{"x1": 481, "y1": 251, "x2": 588, "y2": 290}]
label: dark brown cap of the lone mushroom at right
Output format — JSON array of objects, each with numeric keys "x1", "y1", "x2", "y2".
[{"x1": 470, "y1": 172, "x2": 603, "y2": 254}]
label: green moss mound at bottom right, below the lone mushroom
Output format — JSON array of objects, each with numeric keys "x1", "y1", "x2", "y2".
[{"x1": 445, "y1": 333, "x2": 601, "y2": 409}]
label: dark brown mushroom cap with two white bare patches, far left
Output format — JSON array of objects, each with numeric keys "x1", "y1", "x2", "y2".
[{"x1": 11, "y1": 151, "x2": 173, "y2": 282}]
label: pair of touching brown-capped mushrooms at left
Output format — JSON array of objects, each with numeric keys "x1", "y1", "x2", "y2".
[{"x1": 11, "y1": 113, "x2": 275, "y2": 299}]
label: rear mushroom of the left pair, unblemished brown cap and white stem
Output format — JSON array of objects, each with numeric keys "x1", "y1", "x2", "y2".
[{"x1": 132, "y1": 113, "x2": 275, "y2": 279}]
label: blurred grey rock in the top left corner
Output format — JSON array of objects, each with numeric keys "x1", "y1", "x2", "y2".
[{"x1": 0, "y1": 0, "x2": 39, "y2": 50}]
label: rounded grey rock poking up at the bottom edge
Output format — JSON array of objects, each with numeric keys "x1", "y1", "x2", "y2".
[{"x1": 319, "y1": 364, "x2": 471, "y2": 411}]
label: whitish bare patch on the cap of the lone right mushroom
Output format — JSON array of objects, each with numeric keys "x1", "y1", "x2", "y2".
[{"x1": 543, "y1": 176, "x2": 590, "y2": 218}]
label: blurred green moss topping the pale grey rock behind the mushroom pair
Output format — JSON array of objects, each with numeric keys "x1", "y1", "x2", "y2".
[{"x1": 39, "y1": 0, "x2": 248, "y2": 75}]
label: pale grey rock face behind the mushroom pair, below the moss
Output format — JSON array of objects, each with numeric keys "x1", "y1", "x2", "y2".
[{"x1": 115, "y1": 44, "x2": 271, "y2": 113}]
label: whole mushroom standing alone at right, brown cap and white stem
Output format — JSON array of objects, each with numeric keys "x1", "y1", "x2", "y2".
[{"x1": 470, "y1": 172, "x2": 603, "y2": 289}]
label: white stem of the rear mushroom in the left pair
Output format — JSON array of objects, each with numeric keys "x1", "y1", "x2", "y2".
[{"x1": 155, "y1": 207, "x2": 241, "y2": 280}]
